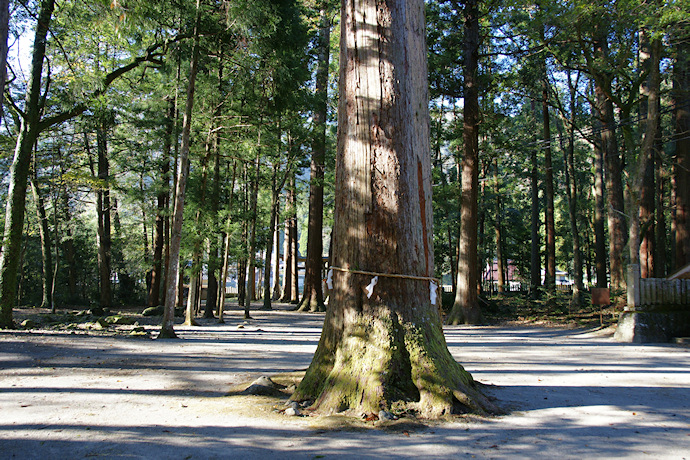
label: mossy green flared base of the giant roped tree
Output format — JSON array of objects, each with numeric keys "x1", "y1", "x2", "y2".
[{"x1": 292, "y1": 309, "x2": 502, "y2": 418}]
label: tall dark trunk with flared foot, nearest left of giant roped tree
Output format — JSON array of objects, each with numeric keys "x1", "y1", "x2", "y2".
[{"x1": 299, "y1": 2, "x2": 331, "y2": 312}]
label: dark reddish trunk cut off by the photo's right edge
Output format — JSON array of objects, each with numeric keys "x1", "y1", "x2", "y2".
[{"x1": 673, "y1": 25, "x2": 690, "y2": 270}]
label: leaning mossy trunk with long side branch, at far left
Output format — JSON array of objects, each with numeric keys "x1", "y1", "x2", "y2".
[{"x1": 0, "y1": 0, "x2": 55, "y2": 328}]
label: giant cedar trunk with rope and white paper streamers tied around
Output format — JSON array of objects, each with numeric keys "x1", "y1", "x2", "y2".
[{"x1": 293, "y1": 0, "x2": 493, "y2": 416}]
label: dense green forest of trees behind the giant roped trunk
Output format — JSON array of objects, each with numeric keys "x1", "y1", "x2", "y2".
[{"x1": 0, "y1": 0, "x2": 690, "y2": 330}]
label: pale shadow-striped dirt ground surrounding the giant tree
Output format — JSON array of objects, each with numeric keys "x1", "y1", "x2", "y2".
[{"x1": 0, "y1": 306, "x2": 690, "y2": 460}]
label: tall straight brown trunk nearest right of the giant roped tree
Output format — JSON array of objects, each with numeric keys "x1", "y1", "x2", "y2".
[{"x1": 447, "y1": 0, "x2": 482, "y2": 324}]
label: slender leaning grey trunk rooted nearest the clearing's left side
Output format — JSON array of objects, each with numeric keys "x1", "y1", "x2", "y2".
[{"x1": 159, "y1": 0, "x2": 201, "y2": 338}]
